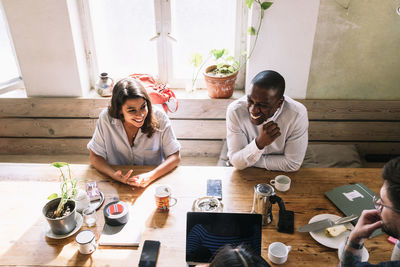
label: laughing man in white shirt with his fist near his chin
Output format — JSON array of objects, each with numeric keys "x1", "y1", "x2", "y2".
[{"x1": 226, "y1": 70, "x2": 308, "y2": 172}]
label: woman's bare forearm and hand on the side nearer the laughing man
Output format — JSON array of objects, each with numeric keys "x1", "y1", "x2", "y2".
[{"x1": 127, "y1": 151, "x2": 181, "y2": 187}]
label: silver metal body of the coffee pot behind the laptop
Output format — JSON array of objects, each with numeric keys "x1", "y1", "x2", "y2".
[{"x1": 251, "y1": 184, "x2": 275, "y2": 225}]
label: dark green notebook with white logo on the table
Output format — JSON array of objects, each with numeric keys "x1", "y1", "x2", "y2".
[{"x1": 325, "y1": 183, "x2": 382, "y2": 237}]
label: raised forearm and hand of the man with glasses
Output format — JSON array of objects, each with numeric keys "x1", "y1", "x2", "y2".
[{"x1": 340, "y1": 210, "x2": 382, "y2": 267}]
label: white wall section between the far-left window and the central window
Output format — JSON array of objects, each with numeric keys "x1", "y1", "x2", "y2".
[{"x1": 2, "y1": 0, "x2": 89, "y2": 97}]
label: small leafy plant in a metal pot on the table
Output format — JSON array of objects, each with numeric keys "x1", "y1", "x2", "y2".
[{"x1": 42, "y1": 162, "x2": 77, "y2": 235}]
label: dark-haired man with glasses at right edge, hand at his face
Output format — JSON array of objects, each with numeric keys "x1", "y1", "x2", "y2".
[{"x1": 340, "y1": 157, "x2": 400, "y2": 267}]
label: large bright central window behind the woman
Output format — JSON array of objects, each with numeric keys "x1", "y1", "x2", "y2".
[{"x1": 87, "y1": 0, "x2": 247, "y2": 87}]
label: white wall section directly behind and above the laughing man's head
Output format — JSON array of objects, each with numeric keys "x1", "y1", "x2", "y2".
[{"x1": 246, "y1": 0, "x2": 320, "y2": 99}]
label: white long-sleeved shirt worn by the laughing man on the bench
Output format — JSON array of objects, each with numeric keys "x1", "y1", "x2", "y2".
[{"x1": 226, "y1": 96, "x2": 308, "y2": 172}]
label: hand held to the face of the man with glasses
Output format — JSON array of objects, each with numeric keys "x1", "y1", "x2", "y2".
[{"x1": 349, "y1": 210, "x2": 382, "y2": 246}]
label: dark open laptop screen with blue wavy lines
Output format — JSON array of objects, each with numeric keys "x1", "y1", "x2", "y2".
[{"x1": 186, "y1": 212, "x2": 262, "y2": 264}]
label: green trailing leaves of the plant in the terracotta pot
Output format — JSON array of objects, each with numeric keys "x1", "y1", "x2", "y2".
[{"x1": 190, "y1": 0, "x2": 272, "y2": 88}]
